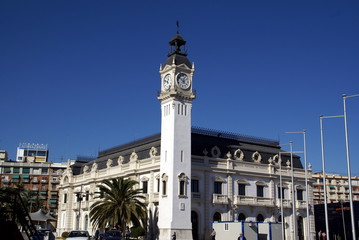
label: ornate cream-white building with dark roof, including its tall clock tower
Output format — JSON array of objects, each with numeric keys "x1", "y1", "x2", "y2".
[{"x1": 57, "y1": 34, "x2": 315, "y2": 240}]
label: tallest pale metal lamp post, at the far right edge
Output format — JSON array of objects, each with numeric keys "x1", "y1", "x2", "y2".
[{"x1": 342, "y1": 94, "x2": 359, "y2": 239}]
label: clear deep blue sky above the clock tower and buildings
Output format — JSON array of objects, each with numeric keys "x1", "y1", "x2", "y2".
[{"x1": 0, "y1": 0, "x2": 359, "y2": 175}]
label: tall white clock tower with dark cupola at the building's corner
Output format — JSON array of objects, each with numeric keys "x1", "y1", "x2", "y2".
[{"x1": 158, "y1": 33, "x2": 195, "y2": 240}]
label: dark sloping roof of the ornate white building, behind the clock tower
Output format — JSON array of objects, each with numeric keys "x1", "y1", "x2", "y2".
[{"x1": 72, "y1": 127, "x2": 303, "y2": 175}]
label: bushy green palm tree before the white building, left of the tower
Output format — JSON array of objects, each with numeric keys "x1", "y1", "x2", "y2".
[{"x1": 90, "y1": 178, "x2": 147, "y2": 229}]
